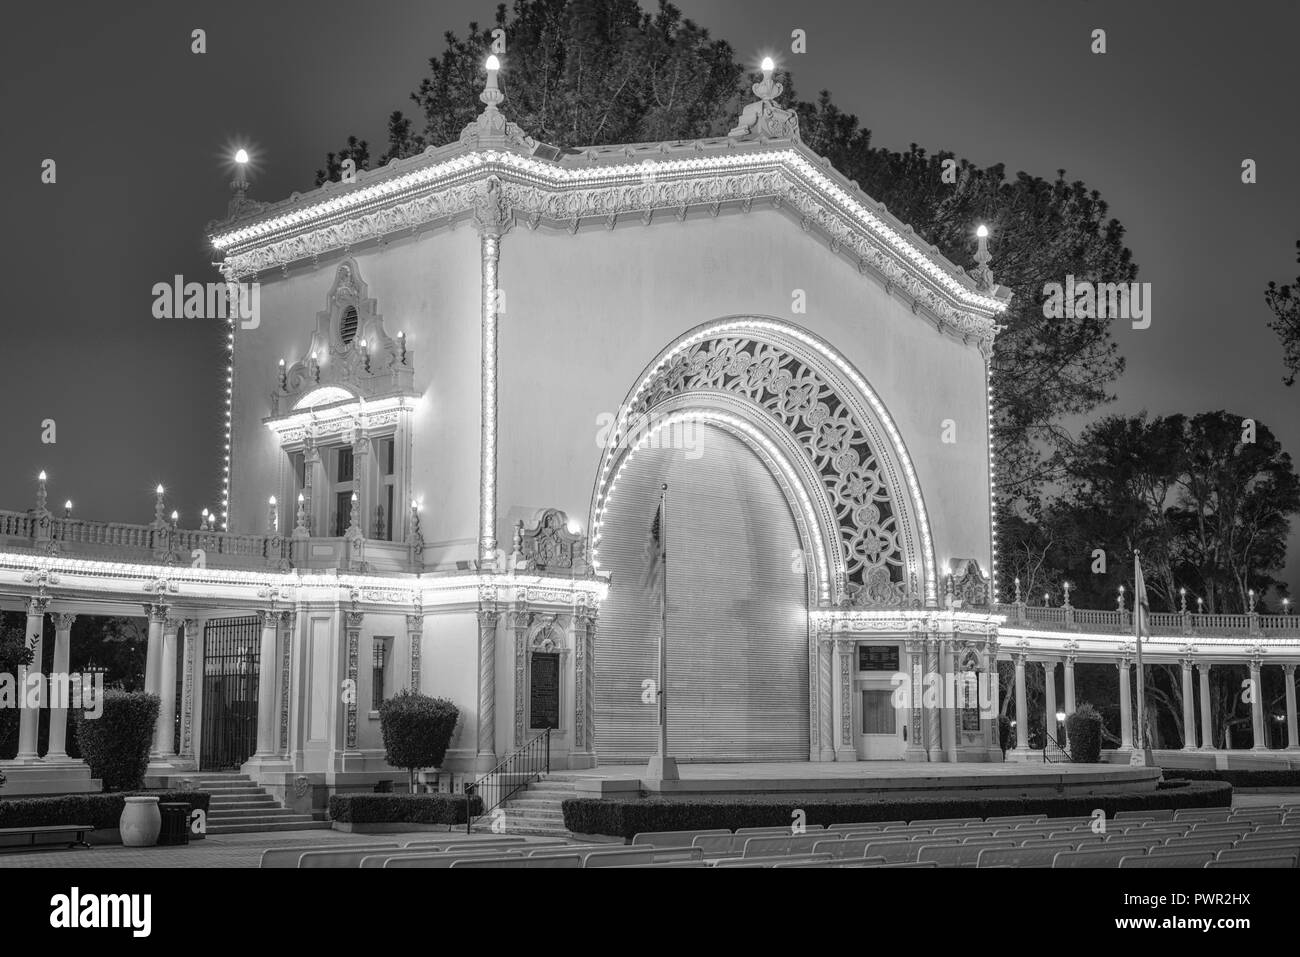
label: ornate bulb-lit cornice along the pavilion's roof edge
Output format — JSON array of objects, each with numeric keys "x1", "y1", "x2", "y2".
[{"x1": 211, "y1": 139, "x2": 1010, "y2": 343}]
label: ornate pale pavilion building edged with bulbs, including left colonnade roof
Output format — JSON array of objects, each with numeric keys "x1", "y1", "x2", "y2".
[{"x1": 0, "y1": 57, "x2": 1055, "y2": 804}]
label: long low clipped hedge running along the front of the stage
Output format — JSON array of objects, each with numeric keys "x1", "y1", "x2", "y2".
[{"x1": 563, "y1": 781, "x2": 1232, "y2": 837}]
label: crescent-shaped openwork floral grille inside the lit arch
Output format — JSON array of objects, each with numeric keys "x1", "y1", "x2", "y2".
[{"x1": 632, "y1": 337, "x2": 907, "y2": 605}]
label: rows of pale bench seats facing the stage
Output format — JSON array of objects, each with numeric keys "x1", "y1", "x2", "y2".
[{"x1": 261, "y1": 804, "x2": 1300, "y2": 869}]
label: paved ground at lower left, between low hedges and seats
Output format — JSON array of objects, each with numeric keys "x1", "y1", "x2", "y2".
[{"x1": 0, "y1": 830, "x2": 556, "y2": 867}]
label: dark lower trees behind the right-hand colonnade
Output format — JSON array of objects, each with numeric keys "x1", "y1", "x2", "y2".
[{"x1": 998, "y1": 411, "x2": 1300, "y2": 614}]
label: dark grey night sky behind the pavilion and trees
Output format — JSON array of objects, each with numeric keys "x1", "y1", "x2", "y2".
[{"x1": 0, "y1": 0, "x2": 1300, "y2": 593}]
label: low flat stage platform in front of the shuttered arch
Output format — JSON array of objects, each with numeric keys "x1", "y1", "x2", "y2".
[{"x1": 546, "y1": 761, "x2": 1161, "y2": 801}]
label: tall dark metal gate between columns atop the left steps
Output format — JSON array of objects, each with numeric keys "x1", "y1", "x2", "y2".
[{"x1": 199, "y1": 615, "x2": 261, "y2": 771}]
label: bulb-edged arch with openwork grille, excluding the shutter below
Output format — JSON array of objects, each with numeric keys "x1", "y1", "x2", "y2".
[{"x1": 588, "y1": 316, "x2": 939, "y2": 607}]
